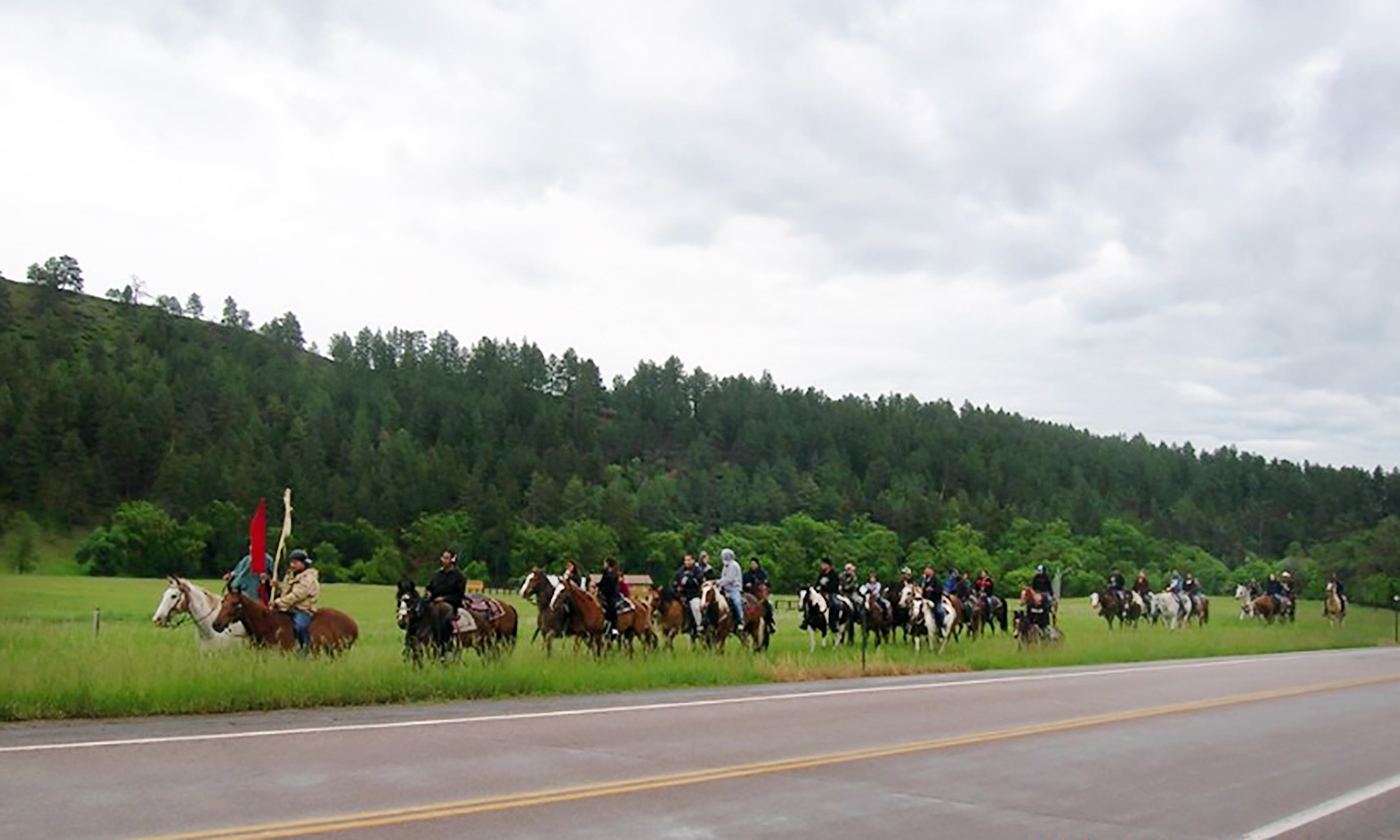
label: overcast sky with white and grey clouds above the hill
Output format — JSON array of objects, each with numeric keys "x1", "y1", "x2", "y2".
[{"x1": 0, "y1": 0, "x2": 1400, "y2": 469}]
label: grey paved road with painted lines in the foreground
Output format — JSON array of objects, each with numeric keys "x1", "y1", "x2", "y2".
[{"x1": 0, "y1": 648, "x2": 1400, "y2": 840}]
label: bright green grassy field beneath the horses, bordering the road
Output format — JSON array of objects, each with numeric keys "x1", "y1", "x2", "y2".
[{"x1": 0, "y1": 575, "x2": 1392, "y2": 721}]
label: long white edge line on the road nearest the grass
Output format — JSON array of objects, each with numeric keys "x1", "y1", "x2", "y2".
[{"x1": 0, "y1": 648, "x2": 1389, "y2": 755}]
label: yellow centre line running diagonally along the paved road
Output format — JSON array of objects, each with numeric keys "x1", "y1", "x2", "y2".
[{"x1": 133, "y1": 673, "x2": 1400, "y2": 840}]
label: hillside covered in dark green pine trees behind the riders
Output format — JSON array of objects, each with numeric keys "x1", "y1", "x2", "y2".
[{"x1": 0, "y1": 260, "x2": 1400, "y2": 599}]
